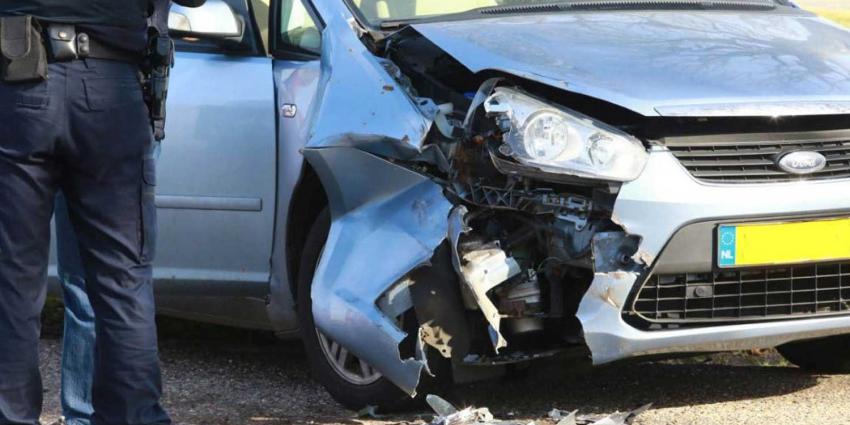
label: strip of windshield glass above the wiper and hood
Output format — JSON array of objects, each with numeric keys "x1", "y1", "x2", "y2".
[{"x1": 349, "y1": 0, "x2": 787, "y2": 27}]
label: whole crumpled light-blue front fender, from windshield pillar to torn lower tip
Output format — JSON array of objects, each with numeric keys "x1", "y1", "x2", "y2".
[{"x1": 292, "y1": 2, "x2": 464, "y2": 395}]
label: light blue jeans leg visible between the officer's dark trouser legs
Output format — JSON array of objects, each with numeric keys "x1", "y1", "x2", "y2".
[{"x1": 55, "y1": 195, "x2": 95, "y2": 425}]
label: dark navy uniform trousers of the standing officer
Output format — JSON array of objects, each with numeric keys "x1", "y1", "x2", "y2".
[{"x1": 0, "y1": 60, "x2": 170, "y2": 425}]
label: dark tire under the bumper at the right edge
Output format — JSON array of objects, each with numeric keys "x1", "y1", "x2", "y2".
[{"x1": 777, "y1": 335, "x2": 850, "y2": 374}]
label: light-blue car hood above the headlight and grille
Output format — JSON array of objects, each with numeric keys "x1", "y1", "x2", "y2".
[{"x1": 414, "y1": 9, "x2": 850, "y2": 116}]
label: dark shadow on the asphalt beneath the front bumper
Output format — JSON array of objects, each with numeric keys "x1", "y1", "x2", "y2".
[{"x1": 444, "y1": 354, "x2": 818, "y2": 414}]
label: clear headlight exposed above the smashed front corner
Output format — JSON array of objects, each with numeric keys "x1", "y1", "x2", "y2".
[{"x1": 484, "y1": 87, "x2": 648, "y2": 182}]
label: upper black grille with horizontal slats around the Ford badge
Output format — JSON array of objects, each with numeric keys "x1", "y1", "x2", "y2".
[{"x1": 667, "y1": 132, "x2": 850, "y2": 183}]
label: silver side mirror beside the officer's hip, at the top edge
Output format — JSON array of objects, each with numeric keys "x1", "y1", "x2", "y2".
[{"x1": 168, "y1": 0, "x2": 244, "y2": 39}]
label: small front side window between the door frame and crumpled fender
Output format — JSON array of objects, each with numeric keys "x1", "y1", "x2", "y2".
[{"x1": 279, "y1": 0, "x2": 322, "y2": 54}]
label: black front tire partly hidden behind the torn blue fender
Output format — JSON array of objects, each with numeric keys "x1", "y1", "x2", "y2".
[{"x1": 297, "y1": 210, "x2": 412, "y2": 411}]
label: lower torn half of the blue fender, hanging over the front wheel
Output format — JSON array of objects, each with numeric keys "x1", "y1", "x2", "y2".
[{"x1": 304, "y1": 148, "x2": 452, "y2": 395}]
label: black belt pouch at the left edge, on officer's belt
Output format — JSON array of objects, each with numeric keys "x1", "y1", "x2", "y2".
[{"x1": 0, "y1": 16, "x2": 47, "y2": 83}]
